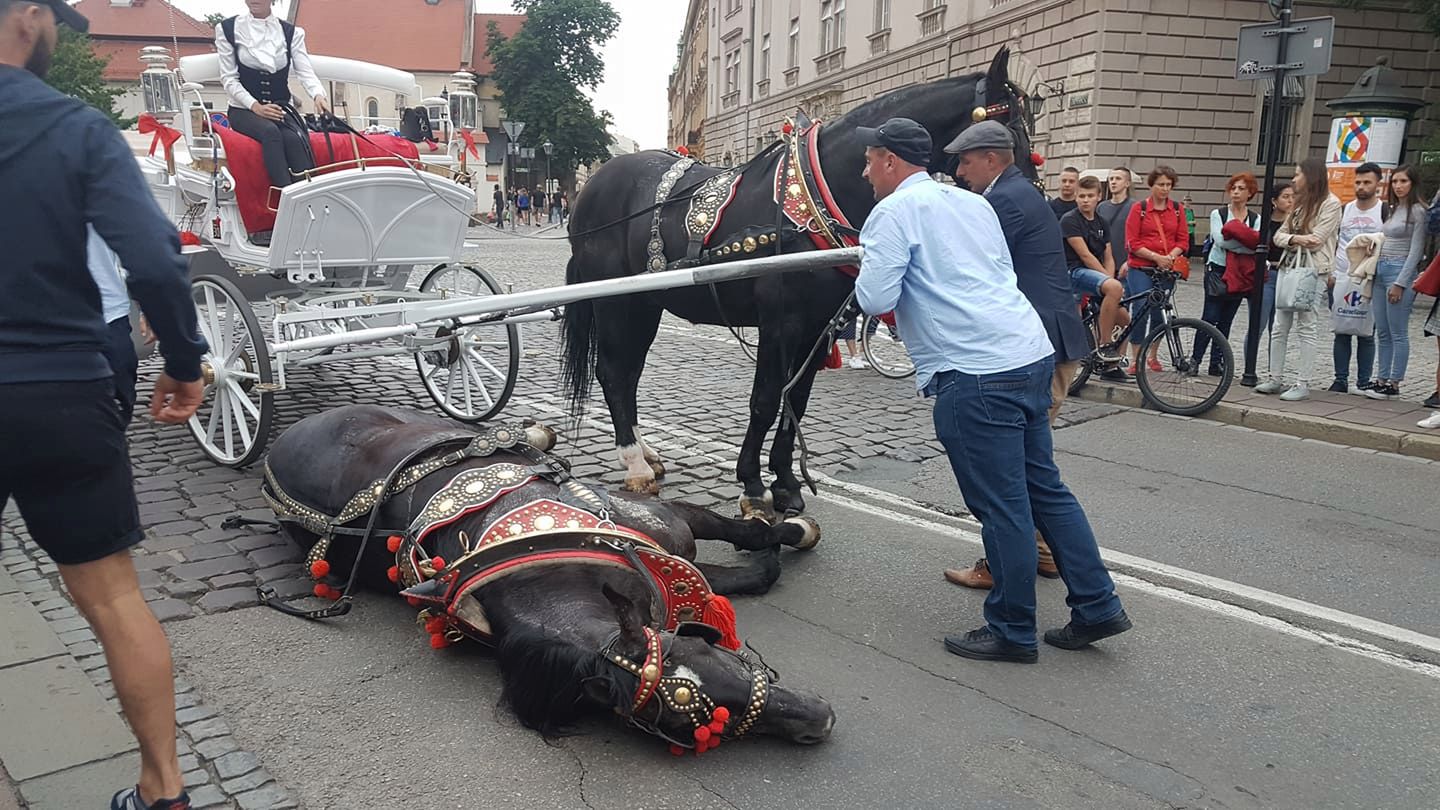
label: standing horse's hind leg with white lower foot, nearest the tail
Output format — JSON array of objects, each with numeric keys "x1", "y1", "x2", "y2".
[{"x1": 595, "y1": 297, "x2": 661, "y2": 493}]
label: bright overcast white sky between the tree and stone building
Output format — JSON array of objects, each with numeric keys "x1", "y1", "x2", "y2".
[{"x1": 174, "y1": 0, "x2": 687, "y2": 148}]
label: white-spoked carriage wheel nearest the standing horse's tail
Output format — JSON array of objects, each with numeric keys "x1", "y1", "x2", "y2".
[{"x1": 415, "y1": 264, "x2": 520, "y2": 422}]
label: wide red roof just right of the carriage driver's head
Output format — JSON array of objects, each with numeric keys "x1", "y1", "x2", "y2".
[{"x1": 292, "y1": 0, "x2": 469, "y2": 74}]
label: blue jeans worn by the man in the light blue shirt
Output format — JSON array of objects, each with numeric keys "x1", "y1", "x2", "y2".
[{"x1": 932, "y1": 356, "x2": 1122, "y2": 649}]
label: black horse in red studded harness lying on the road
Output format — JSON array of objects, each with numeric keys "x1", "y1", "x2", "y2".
[{"x1": 264, "y1": 405, "x2": 835, "y2": 754}]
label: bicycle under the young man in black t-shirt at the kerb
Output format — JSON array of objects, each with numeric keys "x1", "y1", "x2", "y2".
[{"x1": 1068, "y1": 268, "x2": 1236, "y2": 417}]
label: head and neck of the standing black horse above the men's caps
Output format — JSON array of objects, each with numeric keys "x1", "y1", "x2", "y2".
[{"x1": 819, "y1": 48, "x2": 1040, "y2": 220}]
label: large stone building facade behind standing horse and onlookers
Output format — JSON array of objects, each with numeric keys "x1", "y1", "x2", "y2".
[{"x1": 683, "y1": 0, "x2": 1440, "y2": 217}]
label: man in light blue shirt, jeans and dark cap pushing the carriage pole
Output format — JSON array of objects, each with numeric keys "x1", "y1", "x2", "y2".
[{"x1": 855, "y1": 118, "x2": 1130, "y2": 663}]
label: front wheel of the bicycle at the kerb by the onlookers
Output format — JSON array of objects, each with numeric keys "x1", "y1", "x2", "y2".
[{"x1": 1136, "y1": 319, "x2": 1236, "y2": 417}]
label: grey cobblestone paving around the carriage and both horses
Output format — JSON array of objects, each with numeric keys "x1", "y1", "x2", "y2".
[{"x1": 0, "y1": 229, "x2": 1434, "y2": 810}]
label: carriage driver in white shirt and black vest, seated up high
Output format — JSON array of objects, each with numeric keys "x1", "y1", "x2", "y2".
[{"x1": 215, "y1": 0, "x2": 330, "y2": 189}]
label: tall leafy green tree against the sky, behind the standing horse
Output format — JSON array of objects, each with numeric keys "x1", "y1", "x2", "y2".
[{"x1": 488, "y1": 0, "x2": 621, "y2": 182}]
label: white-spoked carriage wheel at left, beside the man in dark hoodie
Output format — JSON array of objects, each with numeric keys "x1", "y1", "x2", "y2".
[{"x1": 189, "y1": 275, "x2": 275, "y2": 467}]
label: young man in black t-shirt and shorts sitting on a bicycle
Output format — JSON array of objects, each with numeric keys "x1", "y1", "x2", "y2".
[{"x1": 1060, "y1": 177, "x2": 1129, "y2": 363}]
